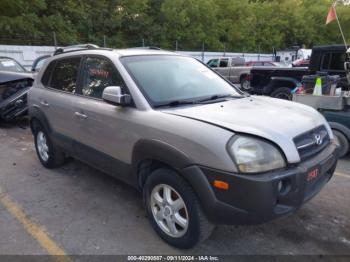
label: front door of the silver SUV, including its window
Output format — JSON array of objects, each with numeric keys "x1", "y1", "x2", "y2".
[{"x1": 74, "y1": 56, "x2": 136, "y2": 179}]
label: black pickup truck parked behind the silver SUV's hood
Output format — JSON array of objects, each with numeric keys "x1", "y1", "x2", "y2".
[{"x1": 250, "y1": 45, "x2": 349, "y2": 100}]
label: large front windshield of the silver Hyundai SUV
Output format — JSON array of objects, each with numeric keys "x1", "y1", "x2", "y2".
[{"x1": 121, "y1": 55, "x2": 242, "y2": 106}]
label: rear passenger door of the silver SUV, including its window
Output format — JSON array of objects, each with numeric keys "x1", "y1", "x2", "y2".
[{"x1": 38, "y1": 56, "x2": 81, "y2": 146}]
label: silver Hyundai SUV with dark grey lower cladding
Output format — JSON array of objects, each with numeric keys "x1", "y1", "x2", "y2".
[{"x1": 29, "y1": 48, "x2": 338, "y2": 248}]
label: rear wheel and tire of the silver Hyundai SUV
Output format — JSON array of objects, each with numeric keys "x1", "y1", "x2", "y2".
[{"x1": 34, "y1": 124, "x2": 65, "y2": 169}]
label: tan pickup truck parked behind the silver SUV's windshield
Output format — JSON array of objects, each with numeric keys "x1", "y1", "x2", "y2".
[{"x1": 207, "y1": 57, "x2": 253, "y2": 91}]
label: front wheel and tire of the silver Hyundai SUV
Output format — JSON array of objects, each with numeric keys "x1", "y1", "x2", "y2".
[{"x1": 143, "y1": 168, "x2": 214, "y2": 249}]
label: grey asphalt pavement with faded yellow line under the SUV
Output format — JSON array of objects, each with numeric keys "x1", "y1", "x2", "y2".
[{"x1": 0, "y1": 120, "x2": 350, "y2": 255}]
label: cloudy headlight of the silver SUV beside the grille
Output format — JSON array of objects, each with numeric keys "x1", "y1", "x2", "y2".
[{"x1": 228, "y1": 136, "x2": 286, "y2": 173}]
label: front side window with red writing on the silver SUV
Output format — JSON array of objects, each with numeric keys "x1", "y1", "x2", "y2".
[{"x1": 82, "y1": 57, "x2": 124, "y2": 98}]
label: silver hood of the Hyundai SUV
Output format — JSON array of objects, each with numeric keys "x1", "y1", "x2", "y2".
[{"x1": 163, "y1": 96, "x2": 333, "y2": 163}]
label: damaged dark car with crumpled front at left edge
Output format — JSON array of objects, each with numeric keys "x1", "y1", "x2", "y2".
[{"x1": 0, "y1": 57, "x2": 34, "y2": 121}]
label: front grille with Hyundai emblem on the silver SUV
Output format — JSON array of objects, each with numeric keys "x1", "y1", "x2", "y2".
[{"x1": 294, "y1": 126, "x2": 330, "y2": 160}]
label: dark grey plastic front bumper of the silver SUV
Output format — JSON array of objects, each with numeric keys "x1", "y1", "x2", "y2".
[{"x1": 183, "y1": 141, "x2": 338, "y2": 225}]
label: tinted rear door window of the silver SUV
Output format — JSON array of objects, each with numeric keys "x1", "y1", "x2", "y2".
[{"x1": 50, "y1": 57, "x2": 80, "y2": 94}]
